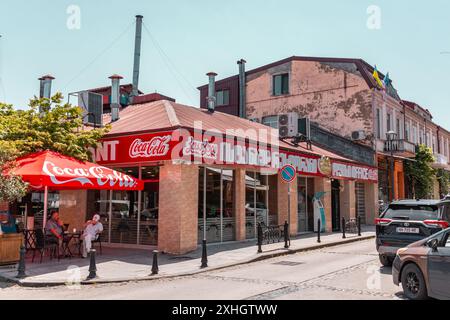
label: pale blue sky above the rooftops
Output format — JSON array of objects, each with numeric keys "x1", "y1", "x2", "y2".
[{"x1": 0, "y1": 0, "x2": 450, "y2": 129}]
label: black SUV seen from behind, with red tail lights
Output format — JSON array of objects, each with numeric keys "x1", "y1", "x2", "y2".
[{"x1": 375, "y1": 200, "x2": 450, "y2": 266}]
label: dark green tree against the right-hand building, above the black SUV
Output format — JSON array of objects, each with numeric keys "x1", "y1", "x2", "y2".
[{"x1": 405, "y1": 144, "x2": 436, "y2": 199}]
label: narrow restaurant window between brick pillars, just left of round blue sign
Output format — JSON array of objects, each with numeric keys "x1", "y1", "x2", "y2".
[{"x1": 245, "y1": 171, "x2": 269, "y2": 239}]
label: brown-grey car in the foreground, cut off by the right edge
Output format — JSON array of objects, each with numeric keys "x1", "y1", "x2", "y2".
[{"x1": 392, "y1": 228, "x2": 450, "y2": 300}]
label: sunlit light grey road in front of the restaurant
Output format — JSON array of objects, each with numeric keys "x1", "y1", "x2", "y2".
[{"x1": 0, "y1": 240, "x2": 403, "y2": 300}]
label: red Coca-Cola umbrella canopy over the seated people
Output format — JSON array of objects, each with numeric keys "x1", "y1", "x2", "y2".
[{"x1": 7, "y1": 151, "x2": 144, "y2": 190}]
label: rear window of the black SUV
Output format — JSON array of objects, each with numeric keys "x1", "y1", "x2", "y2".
[{"x1": 383, "y1": 204, "x2": 438, "y2": 221}]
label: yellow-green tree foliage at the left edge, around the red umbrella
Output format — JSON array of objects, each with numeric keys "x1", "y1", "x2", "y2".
[{"x1": 0, "y1": 93, "x2": 110, "y2": 201}]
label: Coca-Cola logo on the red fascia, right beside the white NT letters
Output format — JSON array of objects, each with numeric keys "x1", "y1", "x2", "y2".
[{"x1": 129, "y1": 135, "x2": 172, "y2": 158}]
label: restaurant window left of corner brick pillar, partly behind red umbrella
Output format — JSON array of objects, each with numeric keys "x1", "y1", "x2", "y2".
[{"x1": 86, "y1": 166, "x2": 159, "y2": 245}]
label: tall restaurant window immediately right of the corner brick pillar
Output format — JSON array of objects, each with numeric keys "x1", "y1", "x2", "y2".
[{"x1": 198, "y1": 167, "x2": 236, "y2": 243}]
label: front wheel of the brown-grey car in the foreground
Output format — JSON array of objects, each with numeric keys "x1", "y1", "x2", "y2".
[{"x1": 401, "y1": 263, "x2": 428, "y2": 300}]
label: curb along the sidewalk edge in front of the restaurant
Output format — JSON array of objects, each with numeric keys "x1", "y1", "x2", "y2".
[{"x1": 0, "y1": 235, "x2": 375, "y2": 288}]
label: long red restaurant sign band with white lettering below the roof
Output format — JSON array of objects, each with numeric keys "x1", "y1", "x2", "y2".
[{"x1": 94, "y1": 130, "x2": 378, "y2": 182}]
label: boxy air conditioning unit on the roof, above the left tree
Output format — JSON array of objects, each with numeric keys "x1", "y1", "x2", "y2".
[{"x1": 78, "y1": 91, "x2": 103, "y2": 127}]
